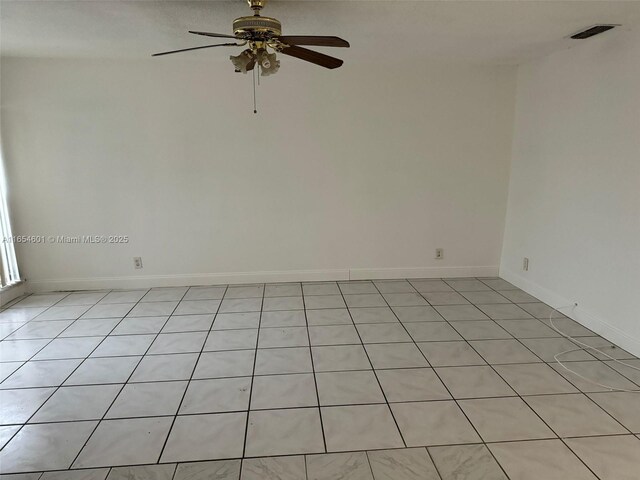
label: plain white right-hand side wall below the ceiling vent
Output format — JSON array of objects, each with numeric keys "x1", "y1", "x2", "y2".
[{"x1": 501, "y1": 29, "x2": 640, "y2": 354}]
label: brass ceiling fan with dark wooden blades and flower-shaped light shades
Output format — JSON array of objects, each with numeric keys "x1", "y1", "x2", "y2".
[{"x1": 152, "y1": 0, "x2": 349, "y2": 76}]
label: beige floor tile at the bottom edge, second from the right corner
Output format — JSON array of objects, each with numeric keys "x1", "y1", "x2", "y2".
[{"x1": 489, "y1": 440, "x2": 597, "y2": 480}]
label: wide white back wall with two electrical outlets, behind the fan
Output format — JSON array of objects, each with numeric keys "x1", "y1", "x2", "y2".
[{"x1": 1, "y1": 58, "x2": 515, "y2": 290}]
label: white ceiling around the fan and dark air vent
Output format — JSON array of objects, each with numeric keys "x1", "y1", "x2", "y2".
[{"x1": 0, "y1": 0, "x2": 640, "y2": 68}]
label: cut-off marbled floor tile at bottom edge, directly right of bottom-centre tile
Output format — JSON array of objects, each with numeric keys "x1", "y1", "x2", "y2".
[{"x1": 367, "y1": 448, "x2": 440, "y2": 480}]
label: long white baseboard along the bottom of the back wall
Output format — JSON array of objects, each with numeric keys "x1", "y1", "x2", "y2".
[{"x1": 28, "y1": 266, "x2": 498, "y2": 293}]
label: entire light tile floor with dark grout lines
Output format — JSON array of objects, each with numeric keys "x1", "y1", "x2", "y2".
[{"x1": 0, "y1": 278, "x2": 640, "y2": 480}]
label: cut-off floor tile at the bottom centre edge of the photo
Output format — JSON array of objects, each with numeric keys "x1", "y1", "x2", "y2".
[{"x1": 306, "y1": 452, "x2": 373, "y2": 480}]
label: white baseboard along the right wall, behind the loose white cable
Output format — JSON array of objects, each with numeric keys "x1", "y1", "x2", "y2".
[{"x1": 500, "y1": 269, "x2": 640, "y2": 356}]
